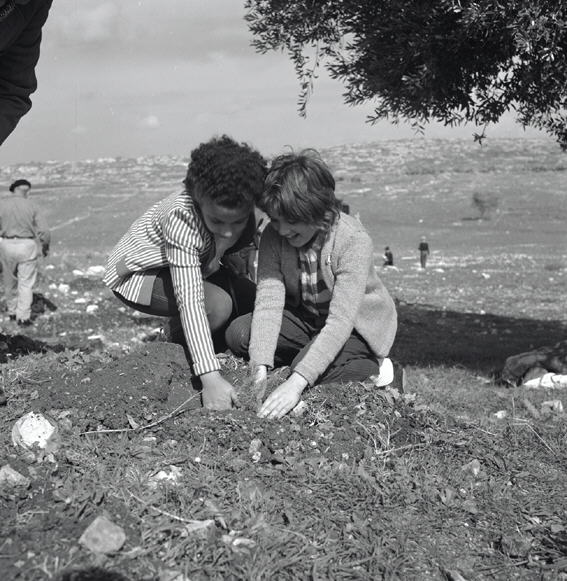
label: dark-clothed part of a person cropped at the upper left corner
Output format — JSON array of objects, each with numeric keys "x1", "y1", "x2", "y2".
[{"x1": 0, "y1": 0, "x2": 53, "y2": 145}]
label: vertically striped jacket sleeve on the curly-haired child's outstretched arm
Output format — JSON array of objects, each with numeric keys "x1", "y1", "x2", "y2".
[{"x1": 163, "y1": 207, "x2": 220, "y2": 375}]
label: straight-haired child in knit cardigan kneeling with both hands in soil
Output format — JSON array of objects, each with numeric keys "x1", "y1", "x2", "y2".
[{"x1": 226, "y1": 150, "x2": 404, "y2": 418}]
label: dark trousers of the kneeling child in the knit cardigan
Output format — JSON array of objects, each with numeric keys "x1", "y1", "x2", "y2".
[{"x1": 226, "y1": 310, "x2": 380, "y2": 383}]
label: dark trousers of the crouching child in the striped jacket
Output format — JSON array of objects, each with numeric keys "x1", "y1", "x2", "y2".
[{"x1": 114, "y1": 268, "x2": 256, "y2": 352}]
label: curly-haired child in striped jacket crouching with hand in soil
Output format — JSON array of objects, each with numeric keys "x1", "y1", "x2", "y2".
[{"x1": 104, "y1": 135, "x2": 266, "y2": 409}]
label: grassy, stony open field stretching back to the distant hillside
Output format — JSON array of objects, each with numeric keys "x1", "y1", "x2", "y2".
[{"x1": 0, "y1": 140, "x2": 567, "y2": 581}]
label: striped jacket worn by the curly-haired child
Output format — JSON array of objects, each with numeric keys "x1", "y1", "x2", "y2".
[{"x1": 104, "y1": 191, "x2": 254, "y2": 375}]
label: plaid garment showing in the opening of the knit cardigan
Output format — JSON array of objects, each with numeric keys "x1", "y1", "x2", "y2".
[{"x1": 299, "y1": 232, "x2": 331, "y2": 327}]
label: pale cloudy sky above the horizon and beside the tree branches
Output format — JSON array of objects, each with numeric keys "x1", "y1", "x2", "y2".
[{"x1": 0, "y1": 0, "x2": 536, "y2": 164}]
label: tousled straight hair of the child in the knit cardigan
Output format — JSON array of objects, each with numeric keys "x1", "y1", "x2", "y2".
[{"x1": 258, "y1": 149, "x2": 340, "y2": 228}]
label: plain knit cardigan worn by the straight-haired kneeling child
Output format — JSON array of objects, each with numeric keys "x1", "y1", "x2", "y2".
[{"x1": 249, "y1": 213, "x2": 397, "y2": 385}]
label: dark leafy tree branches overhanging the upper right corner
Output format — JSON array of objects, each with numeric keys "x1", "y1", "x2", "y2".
[{"x1": 245, "y1": 0, "x2": 567, "y2": 149}]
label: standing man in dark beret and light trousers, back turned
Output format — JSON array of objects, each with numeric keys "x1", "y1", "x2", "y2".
[{"x1": 0, "y1": 180, "x2": 50, "y2": 326}]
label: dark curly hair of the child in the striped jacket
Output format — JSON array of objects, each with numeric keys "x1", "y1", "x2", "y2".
[{"x1": 184, "y1": 135, "x2": 266, "y2": 208}]
